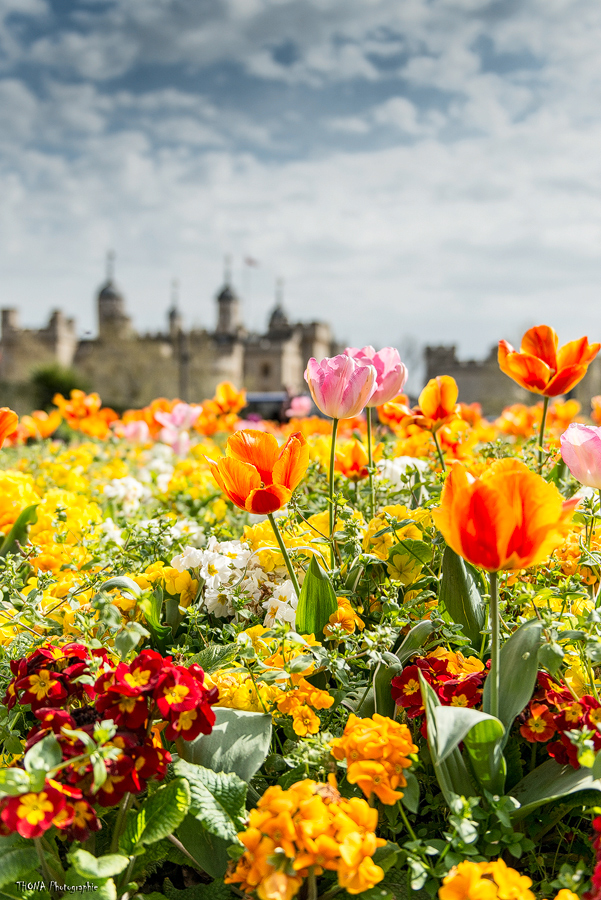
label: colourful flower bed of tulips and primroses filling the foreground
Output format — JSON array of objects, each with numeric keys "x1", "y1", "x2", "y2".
[{"x1": 0, "y1": 326, "x2": 601, "y2": 900}]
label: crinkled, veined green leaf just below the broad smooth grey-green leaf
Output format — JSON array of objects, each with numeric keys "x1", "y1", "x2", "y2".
[{"x1": 175, "y1": 759, "x2": 248, "y2": 843}]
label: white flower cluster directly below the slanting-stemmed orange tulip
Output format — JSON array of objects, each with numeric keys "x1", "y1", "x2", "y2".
[{"x1": 171, "y1": 537, "x2": 297, "y2": 626}]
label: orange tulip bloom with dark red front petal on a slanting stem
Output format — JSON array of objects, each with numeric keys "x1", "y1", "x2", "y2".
[{"x1": 207, "y1": 429, "x2": 309, "y2": 515}]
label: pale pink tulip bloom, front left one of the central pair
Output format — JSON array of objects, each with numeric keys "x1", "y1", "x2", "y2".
[{"x1": 305, "y1": 353, "x2": 377, "y2": 419}]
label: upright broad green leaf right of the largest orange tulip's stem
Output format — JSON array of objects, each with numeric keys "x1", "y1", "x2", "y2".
[{"x1": 482, "y1": 619, "x2": 543, "y2": 741}]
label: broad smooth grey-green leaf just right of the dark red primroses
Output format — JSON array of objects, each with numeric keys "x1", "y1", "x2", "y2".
[{"x1": 177, "y1": 706, "x2": 271, "y2": 781}]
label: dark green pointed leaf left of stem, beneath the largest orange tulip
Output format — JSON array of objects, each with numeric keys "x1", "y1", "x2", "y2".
[{"x1": 440, "y1": 547, "x2": 486, "y2": 650}]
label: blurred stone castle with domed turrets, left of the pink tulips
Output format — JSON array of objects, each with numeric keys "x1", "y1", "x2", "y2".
[{"x1": 0, "y1": 255, "x2": 337, "y2": 412}]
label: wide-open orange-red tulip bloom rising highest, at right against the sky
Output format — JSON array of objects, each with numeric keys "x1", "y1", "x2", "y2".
[{"x1": 499, "y1": 325, "x2": 601, "y2": 397}]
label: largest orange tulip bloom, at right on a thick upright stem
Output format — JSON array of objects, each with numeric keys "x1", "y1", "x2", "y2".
[{"x1": 432, "y1": 459, "x2": 578, "y2": 572}]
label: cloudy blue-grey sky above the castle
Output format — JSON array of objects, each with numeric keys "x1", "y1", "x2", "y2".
[{"x1": 0, "y1": 0, "x2": 601, "y2": 376}]
